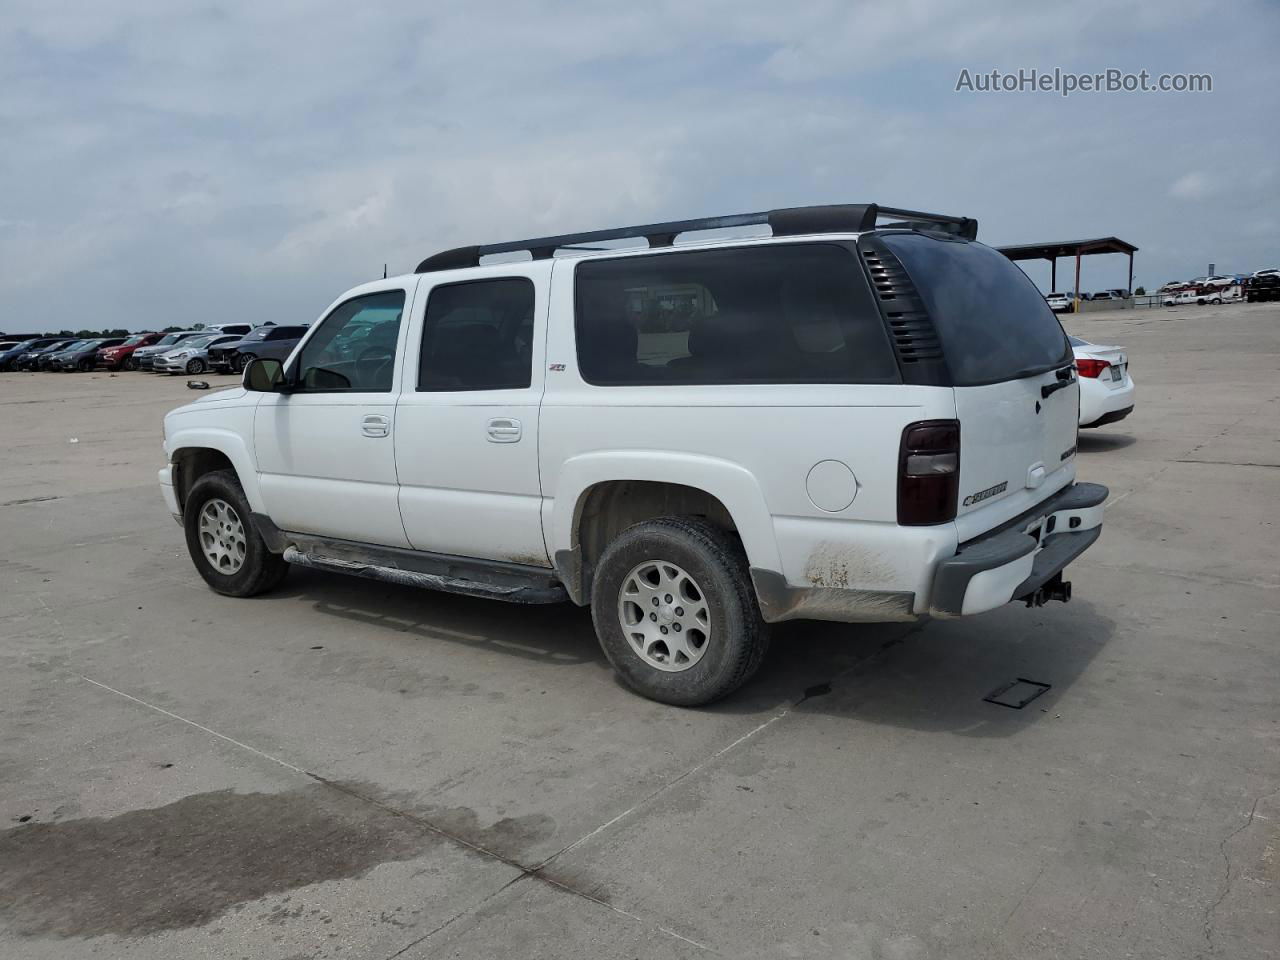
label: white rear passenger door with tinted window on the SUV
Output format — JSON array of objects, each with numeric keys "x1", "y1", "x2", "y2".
[{"x1": 396, "y1": 261, "x2": 550, "y2": 566}]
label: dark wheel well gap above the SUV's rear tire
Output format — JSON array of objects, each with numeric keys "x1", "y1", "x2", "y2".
[{"x1": 573, "y1": 480, "x2": 737, "y2": 598}]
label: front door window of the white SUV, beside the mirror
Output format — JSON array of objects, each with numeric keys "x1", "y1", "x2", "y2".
[{"x1": 296, "y1": 291, "x2": 404, "y2": 393}]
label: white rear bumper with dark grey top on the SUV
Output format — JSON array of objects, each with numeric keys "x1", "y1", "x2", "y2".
[{"x1": 929, "y1": 484, "x2": 1108, "y2": 617}]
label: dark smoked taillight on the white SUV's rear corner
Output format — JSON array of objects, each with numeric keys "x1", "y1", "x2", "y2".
[{"x1": 897, "y1": 420, "x2": 960, "y2": 526}]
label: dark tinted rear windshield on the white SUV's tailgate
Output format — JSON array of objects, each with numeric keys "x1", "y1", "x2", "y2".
[{"x1": 881, "y1": 233, "x2": 1070, "y2": 387}]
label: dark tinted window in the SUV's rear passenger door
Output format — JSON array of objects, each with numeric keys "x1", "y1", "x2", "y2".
[{"x1": 417, "y1": 278, "x2": 534, "y2": 390}]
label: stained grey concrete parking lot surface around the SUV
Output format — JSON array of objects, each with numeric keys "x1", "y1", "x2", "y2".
[{"x1": 0, "y1": 305, "x2": 1280, "y2": 960}]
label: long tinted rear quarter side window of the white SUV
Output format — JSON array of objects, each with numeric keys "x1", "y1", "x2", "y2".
[{"x1": 576, "y1": 243, "x2": 899, "y2": 385}]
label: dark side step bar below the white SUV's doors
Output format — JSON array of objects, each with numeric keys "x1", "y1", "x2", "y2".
[{"x1": 253, "y1": 513, "x2": 568, "y2": 603}]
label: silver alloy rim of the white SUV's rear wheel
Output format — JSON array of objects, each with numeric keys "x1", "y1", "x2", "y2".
[{"x1": 618, "y1": 559, "x2": 712, "y2": 673}]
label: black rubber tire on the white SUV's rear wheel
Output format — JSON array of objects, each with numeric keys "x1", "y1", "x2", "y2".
[{"x1": 591, "y1": 517, "x2": 769, "y2": 707}]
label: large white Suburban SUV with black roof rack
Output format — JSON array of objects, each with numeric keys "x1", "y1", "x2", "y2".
[{"x1": 160, "y1": 205, "x2": 1107, "y2": 705}]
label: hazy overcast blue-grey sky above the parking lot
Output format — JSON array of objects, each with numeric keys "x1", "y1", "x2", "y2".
[{"x1": 0, "y1": 0, "x2": 1280, "y2": 330}]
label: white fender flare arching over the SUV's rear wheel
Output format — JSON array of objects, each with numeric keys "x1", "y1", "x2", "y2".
[{"x1": 547, "y1": 449, "x2": 782, "y2": 601}]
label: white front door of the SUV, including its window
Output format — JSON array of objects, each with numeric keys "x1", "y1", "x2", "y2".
[{"x1": 253, "y1": 278, "x2": 417, "y2": 547}]
